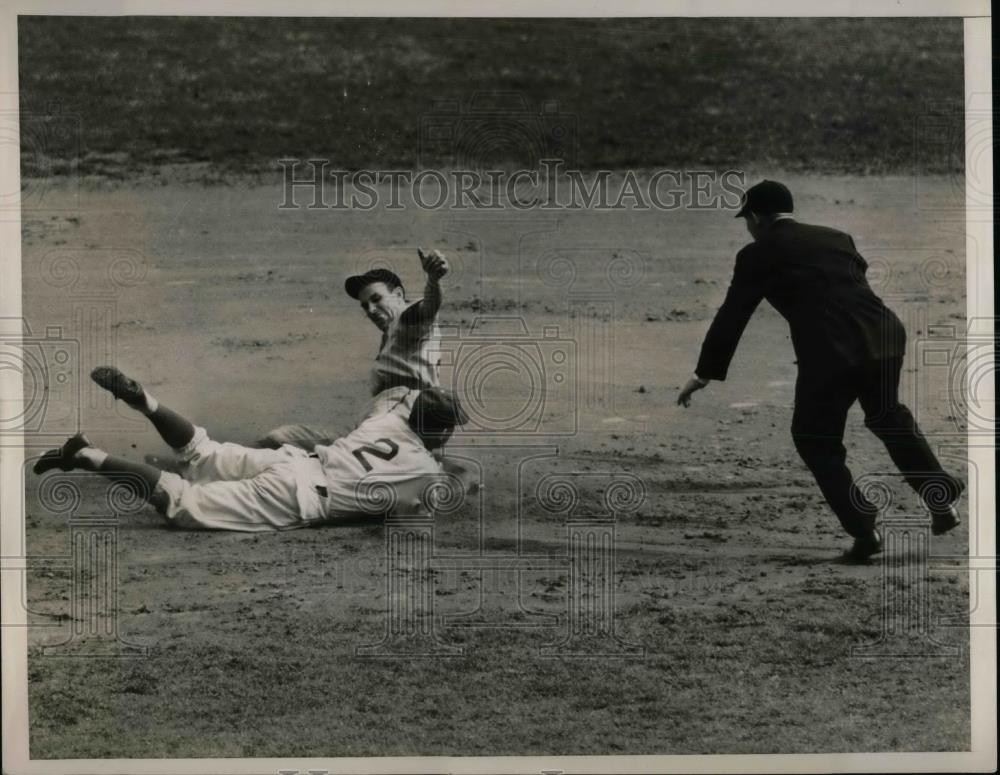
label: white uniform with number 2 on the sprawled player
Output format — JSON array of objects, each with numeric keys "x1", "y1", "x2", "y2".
[{"x1": 157, "y1": 413, "x2": 442, "y2": 532}]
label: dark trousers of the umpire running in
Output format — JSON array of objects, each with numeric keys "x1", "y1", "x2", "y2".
[{"x1": 792, "y1": 358, "x2": 963, "y2": 536}]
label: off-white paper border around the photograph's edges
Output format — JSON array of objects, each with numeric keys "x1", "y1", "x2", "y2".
[{"x1": 0, "y1": 0, "x2": 997, "y2": 775}]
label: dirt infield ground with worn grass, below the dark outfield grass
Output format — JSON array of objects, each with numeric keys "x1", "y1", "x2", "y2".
[{"x1": 17, "y1": 170, "x2": 972, "y2": 758}]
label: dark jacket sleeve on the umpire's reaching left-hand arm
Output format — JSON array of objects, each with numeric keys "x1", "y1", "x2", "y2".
[{"x1": 694, "y1": 248, "x2": 765, "y2": 380}]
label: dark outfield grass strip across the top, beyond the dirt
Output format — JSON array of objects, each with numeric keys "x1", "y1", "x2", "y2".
[{"x1": 19, "y1": 16, "x2": 964, "y2": 177}]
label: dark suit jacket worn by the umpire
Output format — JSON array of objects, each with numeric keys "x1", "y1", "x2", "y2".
[{"x1": 695, "y1": 219, "x2": 906, "y2": 380}]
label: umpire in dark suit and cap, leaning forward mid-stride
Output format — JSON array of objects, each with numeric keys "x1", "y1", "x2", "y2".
[{"x1": 677, "y1": 180, "x2": 963, "y2": 561}]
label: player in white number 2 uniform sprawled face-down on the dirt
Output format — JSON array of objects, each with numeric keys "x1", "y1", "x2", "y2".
[{"x1": 34, "y1": 366, "x2": 467, "y2": 532}]
